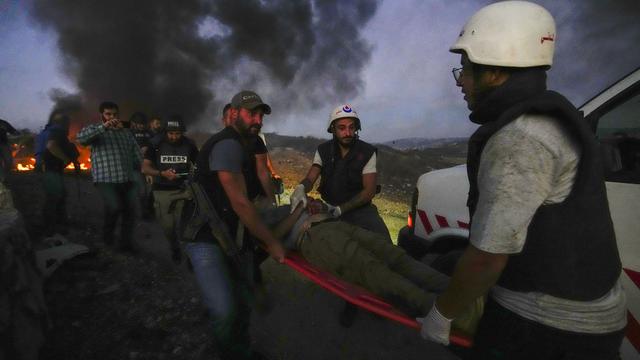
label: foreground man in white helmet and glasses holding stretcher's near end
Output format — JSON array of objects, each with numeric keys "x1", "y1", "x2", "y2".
[{"x1": 422, "y1": 1, "x2": 626, "y2": 359}]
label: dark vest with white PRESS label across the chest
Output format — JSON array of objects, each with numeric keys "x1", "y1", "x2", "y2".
[{"x1": 153, "y1": 137, "x2": 195, "y2": 190}]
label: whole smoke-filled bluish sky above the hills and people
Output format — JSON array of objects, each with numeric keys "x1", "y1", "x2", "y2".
[{"x1": 0, "y1": 0, "x2": 640, "y2": 141}]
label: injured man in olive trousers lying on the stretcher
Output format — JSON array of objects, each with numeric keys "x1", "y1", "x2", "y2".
[{"x1": 260, "y1": 199, "x2": 483, "y2": 334}]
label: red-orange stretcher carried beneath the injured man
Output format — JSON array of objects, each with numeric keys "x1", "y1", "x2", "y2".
[{"x1": 284, "y1": 253, "x2": 472, "y2": 348}]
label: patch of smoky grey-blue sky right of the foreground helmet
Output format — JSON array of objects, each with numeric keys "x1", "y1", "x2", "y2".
[{"x1": 542, "y1": 0, "x2": 640, "y2": 106}]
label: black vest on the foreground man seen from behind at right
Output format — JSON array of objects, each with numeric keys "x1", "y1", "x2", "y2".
[{"x1": 467, "y1": 91, "x2": 621, "y2": 301}]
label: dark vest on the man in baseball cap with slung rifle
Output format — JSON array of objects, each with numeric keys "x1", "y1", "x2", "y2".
[{"x1": 195, "y1": 127, "x2": 260, "y2": 244}]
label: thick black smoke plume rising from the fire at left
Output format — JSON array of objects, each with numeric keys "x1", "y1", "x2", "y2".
[{"x1": 31, "y1": 0, "x2": 378, "y2": 129}]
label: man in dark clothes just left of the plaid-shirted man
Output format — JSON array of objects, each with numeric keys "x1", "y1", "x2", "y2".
[{"x1": 39, "y1": 110, "x2": 80, "y2": 236}]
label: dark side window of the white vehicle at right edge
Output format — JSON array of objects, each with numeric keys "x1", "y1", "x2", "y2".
[{"x1": 596, "y1": 93, "x2": 640, "y2": 184}]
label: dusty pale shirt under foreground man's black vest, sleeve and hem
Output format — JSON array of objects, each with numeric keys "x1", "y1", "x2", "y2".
[{"x1": 470, "y1": 114, "x2": 626, "y2": 334}]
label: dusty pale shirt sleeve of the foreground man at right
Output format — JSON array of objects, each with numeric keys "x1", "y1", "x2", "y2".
[{"x1": 470, "y1": 115, "x2": 580, "y2": 254}]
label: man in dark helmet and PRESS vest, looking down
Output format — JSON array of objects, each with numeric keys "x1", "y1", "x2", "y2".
[{"x1": 142, "y1": 115, "x2": 198, "y2": 263}]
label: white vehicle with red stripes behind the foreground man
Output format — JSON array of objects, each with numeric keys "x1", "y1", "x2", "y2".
[{"x1": 398, "y1": 68, "x2": 640, "y2": 360}]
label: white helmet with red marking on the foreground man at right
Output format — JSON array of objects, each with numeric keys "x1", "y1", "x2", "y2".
[{"x1": 449, "y1": 1, "x2": 556, "y2": 67}]
